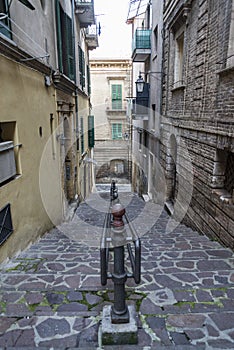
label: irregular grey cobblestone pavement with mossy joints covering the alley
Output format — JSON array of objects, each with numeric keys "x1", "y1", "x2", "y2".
[{"x1": 0, "y1": 187, "x2": 234, "y2": 350}]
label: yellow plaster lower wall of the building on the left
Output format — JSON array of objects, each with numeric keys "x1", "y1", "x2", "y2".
[{"x1": 0, "y1": 56, "x2": 63, "y2": 261}]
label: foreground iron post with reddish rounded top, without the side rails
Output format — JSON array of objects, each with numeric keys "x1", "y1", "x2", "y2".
[{"x1": 111, "y1": 203, "x2": 129, "y2": 323}]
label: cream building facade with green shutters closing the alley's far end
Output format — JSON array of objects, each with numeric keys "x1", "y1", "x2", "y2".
[{"x1": 90, "y1": 58, "x2": 132, "y2": 183}]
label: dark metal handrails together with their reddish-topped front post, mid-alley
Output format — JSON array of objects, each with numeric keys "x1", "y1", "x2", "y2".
[{"x1": 100, "y1": 181, "x2": 141, "y2": 324}]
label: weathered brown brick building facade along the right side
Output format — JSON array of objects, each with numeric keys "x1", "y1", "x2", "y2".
[{"x1": 160, "y1": 0, "x2": 234, "y2": 249}]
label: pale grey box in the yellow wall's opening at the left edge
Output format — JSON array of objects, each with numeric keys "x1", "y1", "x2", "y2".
[{"x1": 0, "y1": 141, "x2": 16, "y2": 184}]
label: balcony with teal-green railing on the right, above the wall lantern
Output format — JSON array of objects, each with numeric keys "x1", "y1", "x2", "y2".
[{"x1": 132, "y1": 28, "x2": 151, "y2": 62}]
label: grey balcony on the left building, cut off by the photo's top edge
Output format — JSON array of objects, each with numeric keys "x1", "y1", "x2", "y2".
[{"x1": 75, "y1": 0, "x2": 95, "y2": 28}]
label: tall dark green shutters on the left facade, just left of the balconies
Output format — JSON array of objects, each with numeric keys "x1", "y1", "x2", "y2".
[{"x1": 56, "y1": 0, "x2": 75, "y2": 80}]
